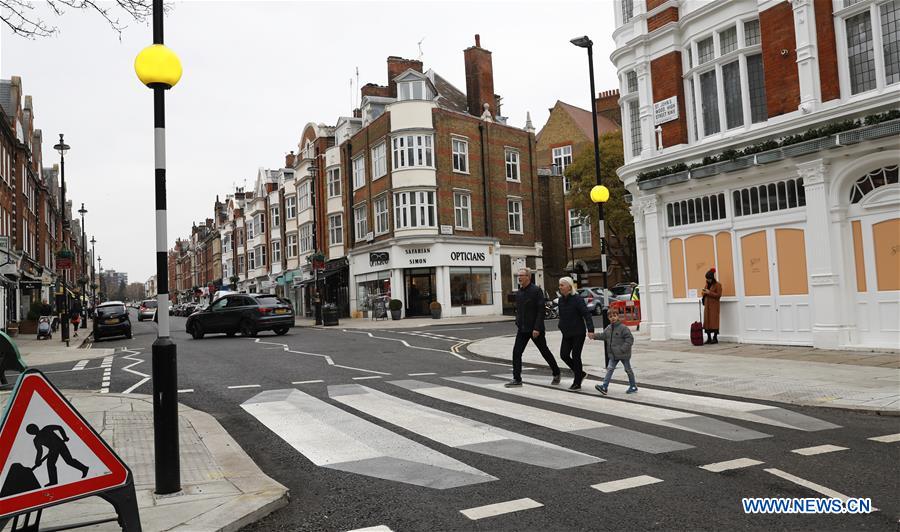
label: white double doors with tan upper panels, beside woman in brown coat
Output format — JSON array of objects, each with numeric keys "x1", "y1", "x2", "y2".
[{"x1": 740, "y1": 227, "x2": 812, "y2": 345}]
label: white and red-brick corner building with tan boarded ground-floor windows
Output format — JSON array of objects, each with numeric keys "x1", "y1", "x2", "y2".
[{"x1": 611, "y1": 0, "x2": 900, "y2": 348}]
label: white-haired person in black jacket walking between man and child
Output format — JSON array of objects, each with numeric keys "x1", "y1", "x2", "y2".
[{"x1": 559, "y1": 277, "x2": 594, "y2": 390}]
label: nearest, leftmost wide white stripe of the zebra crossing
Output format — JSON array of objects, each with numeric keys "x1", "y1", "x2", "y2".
[{"x1": 241, "y1": 388, "x2": 497, "y2": 489}]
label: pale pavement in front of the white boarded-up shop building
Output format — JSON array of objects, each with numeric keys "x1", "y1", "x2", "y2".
[{"x1": 467, "y1": 331, "x2": 900, "y2": 415}]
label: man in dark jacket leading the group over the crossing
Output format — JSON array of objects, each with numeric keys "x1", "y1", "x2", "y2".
[{"x1": 506, "y1": 268, "x2": 559, "y2": 387}]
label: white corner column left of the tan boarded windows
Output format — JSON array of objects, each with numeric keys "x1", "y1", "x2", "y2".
[{"x1": 641, "y1": 194, "x2": 669, "y2": 340}]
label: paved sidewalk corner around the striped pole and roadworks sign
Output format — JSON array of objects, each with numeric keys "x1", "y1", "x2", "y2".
[{"x1": 0, "y1": 329, "x2": 289, "y2": 532}]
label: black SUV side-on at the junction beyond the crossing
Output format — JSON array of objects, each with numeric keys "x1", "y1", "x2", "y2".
[{"x1": 185, "y1": 294, "x2": 294, "y2": 340}]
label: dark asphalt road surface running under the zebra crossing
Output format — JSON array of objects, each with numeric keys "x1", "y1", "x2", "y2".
[{"x1": 28, "y1": 312, "x2": 900, "y2": 531}]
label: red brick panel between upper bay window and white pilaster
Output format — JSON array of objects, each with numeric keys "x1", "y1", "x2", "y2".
[{"x1": 759, "y1": 2, "x2": 800, "y2": 118}]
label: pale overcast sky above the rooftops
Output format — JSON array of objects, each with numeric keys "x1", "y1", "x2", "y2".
[{"x1": 0, "y1": 0, "x2": 617, "y2": 281}]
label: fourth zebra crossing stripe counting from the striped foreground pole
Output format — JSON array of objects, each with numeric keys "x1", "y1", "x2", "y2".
[{"x1": 460, "y1": 377, "x2": 771, "y2": 441}]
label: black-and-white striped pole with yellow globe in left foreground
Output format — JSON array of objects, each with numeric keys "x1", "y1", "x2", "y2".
[{"x1": 134, "y1": 0, "x2": 181, "y2": 494}]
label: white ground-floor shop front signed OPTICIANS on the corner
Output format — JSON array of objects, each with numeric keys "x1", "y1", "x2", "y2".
[{"x1": 349, "y1": 238, "x2": 503, "y2": 318}]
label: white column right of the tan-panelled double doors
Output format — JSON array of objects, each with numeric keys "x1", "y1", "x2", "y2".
[{"x1": 797, "y1": 159, "x2": 852, "y2": 349}]
